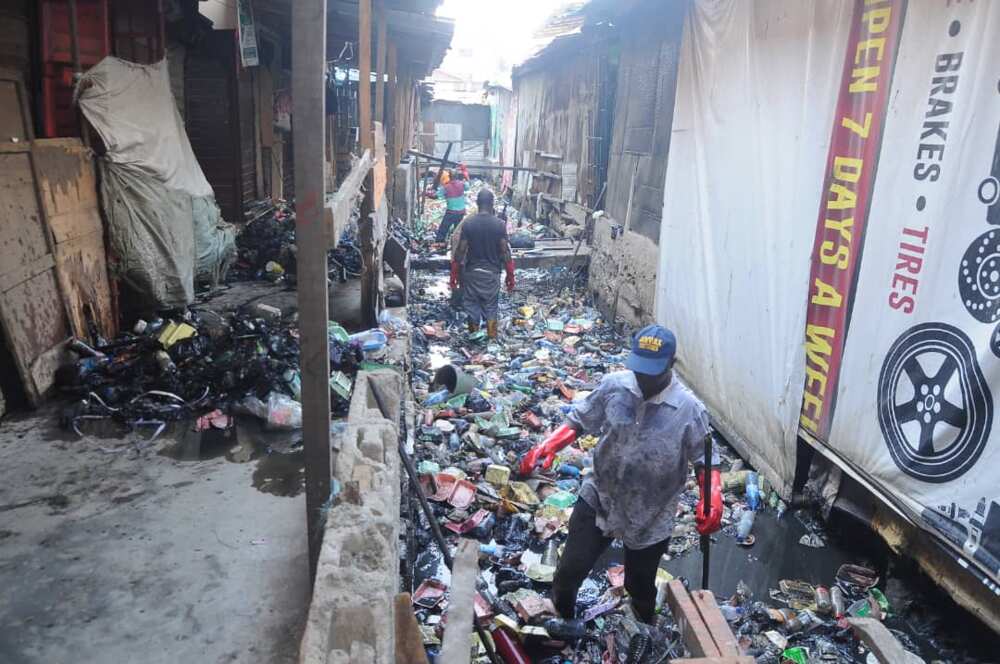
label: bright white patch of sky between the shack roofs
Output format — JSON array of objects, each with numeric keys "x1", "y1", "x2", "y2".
[{"x1": 438, "y1": 0, "x2": 568, "y2": 83}]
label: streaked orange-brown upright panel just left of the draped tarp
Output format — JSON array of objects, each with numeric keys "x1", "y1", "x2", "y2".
[{"x1": 32, "y1": 139, "x2": 117, "y2": 338}]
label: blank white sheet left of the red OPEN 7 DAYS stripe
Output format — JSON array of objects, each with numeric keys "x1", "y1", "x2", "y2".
[{"x1": 657, "y1": 0, "x2": 851, "y2": 494}]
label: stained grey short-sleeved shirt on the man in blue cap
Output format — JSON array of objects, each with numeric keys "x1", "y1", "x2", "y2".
[{"x1": 568, "y1": 371, "x2": 714, "y2": 549}]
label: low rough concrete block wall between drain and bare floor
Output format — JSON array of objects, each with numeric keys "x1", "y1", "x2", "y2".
[{"x1": 299, "y1": 369, "x2": 406, "y2": 664}]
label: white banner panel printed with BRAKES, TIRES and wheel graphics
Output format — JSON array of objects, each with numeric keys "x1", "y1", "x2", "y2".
[{"x1": 820, "y1": 2, "x2": 1000, "y2": 591}]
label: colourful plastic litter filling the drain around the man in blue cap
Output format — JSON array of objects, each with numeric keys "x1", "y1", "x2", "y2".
[{"x1": 400, "y1": 270, "x2": 928, "y2": 664}]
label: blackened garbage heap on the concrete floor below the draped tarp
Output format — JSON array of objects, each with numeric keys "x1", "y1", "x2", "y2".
[{"x1": 57, "y1": 302, "x2": 404, "y2": 436}]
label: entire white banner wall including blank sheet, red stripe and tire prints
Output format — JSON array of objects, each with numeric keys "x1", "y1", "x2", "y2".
[{"x1": 657, "y1": 0, "x2": 1000, "y2": 604}]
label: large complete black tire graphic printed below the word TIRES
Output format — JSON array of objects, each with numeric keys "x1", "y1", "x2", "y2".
[{"x1": 876, "y1": 323, "x2": 993, "y2": 483}]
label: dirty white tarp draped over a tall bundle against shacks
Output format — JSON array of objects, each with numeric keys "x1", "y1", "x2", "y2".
[{"x1": 78, "y1": 57, "x2": 236, "y2": 308}]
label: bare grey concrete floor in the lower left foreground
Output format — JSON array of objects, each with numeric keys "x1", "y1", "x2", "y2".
[{"x1": 0, "y1": 408, "x2": 310, "y2": 664}]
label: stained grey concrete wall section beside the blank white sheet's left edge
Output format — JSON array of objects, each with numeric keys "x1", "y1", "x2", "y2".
[{"x1": 588, "y1": 217, "x2": 660, "y2": 327}]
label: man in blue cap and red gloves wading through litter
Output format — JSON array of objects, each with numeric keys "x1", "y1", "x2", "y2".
[{"x1": 520, "y1": 325, "x2": 722, "y2": 622}]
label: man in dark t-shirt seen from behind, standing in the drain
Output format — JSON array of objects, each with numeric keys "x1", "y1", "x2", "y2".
[{"x1": 450, "y1": 188, "x2": 514, "y2": 339}]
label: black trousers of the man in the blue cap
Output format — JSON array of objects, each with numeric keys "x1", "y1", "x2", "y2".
[{"x1": 552, "y1": 500, "x2": 670, "y2": 623}]
